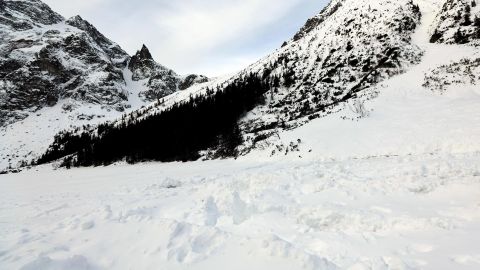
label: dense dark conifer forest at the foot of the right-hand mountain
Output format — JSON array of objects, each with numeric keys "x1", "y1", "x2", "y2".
[{"x1": 35, "y1": 73, "x2": 278, "y2": 167}]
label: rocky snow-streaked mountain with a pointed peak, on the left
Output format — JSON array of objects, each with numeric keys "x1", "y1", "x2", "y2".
[{"x1": 0, "y1": 0, "x2": 208, "y2": 170}]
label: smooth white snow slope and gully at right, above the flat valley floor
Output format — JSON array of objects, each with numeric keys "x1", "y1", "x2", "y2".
[{"x1": 248, "y1": 1, "x2": 480, "y2": 158}]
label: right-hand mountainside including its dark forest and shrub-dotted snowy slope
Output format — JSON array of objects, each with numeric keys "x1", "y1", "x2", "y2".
[{"x1": 34, "y1": 0, "x2": 475, "y2": 168}]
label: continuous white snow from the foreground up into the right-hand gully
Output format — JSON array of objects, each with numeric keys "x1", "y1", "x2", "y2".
[{"x1": 0, "y1": 0, "x2": 480, "y2": 270}]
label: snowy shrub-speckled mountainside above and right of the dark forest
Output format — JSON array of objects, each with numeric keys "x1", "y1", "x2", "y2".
[{"x1": 109, "y1": 0, "x2": 422, "y2": 130}]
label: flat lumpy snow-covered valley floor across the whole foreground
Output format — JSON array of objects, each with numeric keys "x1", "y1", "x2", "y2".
[{"x1": 0, "y1": 152, "x2": 480, "y2": 270}]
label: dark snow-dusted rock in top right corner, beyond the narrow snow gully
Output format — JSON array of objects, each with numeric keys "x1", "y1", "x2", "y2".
[{"x1": 430, "y1": 0, "x2": 480, "y2": 46}]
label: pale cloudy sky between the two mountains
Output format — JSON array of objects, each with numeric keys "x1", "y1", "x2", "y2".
[{"x1": 43, "y1": 0, "x2": 328, "y2": 76}]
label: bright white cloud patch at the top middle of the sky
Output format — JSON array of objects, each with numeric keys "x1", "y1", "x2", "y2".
[{"x1": 156, "y1": 0, "x2": 300, "y2": 50}]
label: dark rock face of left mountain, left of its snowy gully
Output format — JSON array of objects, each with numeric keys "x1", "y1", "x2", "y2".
[{"x1": 0, "y1": 1, "x2": 129, "y2": 126}]
